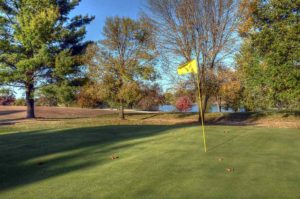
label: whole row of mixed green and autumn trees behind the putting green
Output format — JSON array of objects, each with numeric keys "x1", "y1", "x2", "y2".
[{"x1": 0, "y1": 0, "x2": 300, "y2": 119}]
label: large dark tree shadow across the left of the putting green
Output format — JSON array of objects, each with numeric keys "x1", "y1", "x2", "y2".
[{"x1": 0, "y1": 125, "x2": 178, "y2": 191}]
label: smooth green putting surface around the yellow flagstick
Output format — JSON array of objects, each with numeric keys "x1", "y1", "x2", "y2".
[{"x1": 0, "y1": 119, "x2": 300, "y2": 199}]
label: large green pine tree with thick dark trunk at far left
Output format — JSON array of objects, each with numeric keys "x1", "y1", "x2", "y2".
[{"x1": 0, "y1": 0, "x2": 93, "y2": 118}]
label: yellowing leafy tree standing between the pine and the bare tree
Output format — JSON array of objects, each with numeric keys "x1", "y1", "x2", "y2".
[{"x1": 87, "y1": 17, "x2": 157, "y2": 119}]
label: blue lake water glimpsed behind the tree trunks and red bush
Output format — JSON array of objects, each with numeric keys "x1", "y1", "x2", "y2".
[{"x1": 158, "y1": 104, "x2": 245, "y2": 113}]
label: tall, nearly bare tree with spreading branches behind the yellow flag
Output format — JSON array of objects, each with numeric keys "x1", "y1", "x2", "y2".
[{"x1": 147, "y1": 0, "x2": 239, "y2": 120}]
